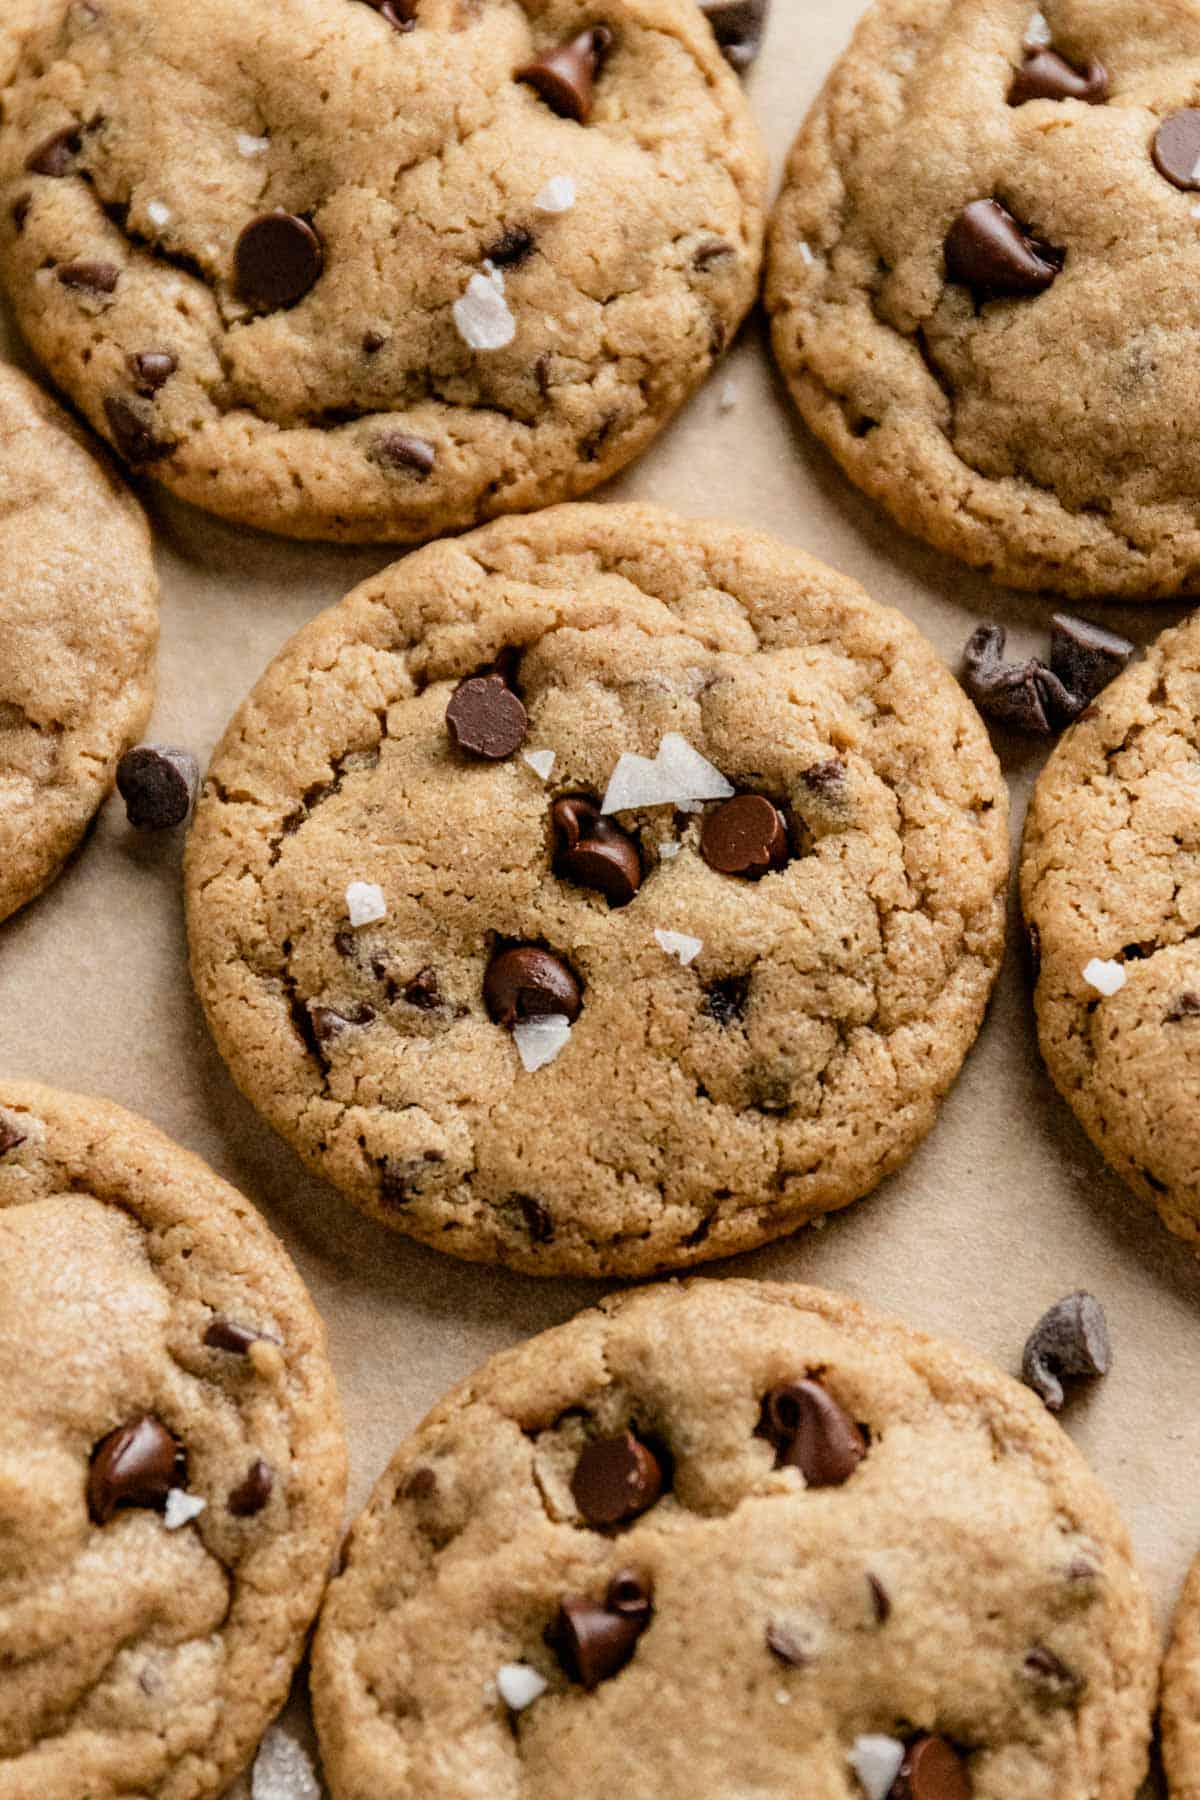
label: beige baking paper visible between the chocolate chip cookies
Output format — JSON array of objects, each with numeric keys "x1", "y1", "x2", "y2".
[{"x1": 0, "y1": 0, "x2": 1200, "y2": 1792}]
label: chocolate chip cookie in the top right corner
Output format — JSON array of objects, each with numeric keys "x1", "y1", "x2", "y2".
[{"x1": 768, "y1": 0, "x2": 1200, "y2": 598}]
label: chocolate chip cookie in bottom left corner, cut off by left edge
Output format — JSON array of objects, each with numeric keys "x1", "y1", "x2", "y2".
[{"x1": 0, "y1": 1082, "x2": 345, "y2": 1800}]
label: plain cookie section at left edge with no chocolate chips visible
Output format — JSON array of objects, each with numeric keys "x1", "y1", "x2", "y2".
[{"x1": 0, "y1": 367, "x2": 158, "y2": 918}]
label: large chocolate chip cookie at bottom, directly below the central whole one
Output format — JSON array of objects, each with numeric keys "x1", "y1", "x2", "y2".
[{"x1": 313, "y1": 1282, "x2": 1157, "y2": 1800}]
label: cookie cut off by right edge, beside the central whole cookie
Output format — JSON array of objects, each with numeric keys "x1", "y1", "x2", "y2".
[{"x1": 1022, "y1": 614, "x2": 1200, "y2": 1244}]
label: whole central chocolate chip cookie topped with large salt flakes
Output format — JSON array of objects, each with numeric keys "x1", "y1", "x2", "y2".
[{"x1": 187, "y1": 506, "x2": 1007, "y2": 1274}]
